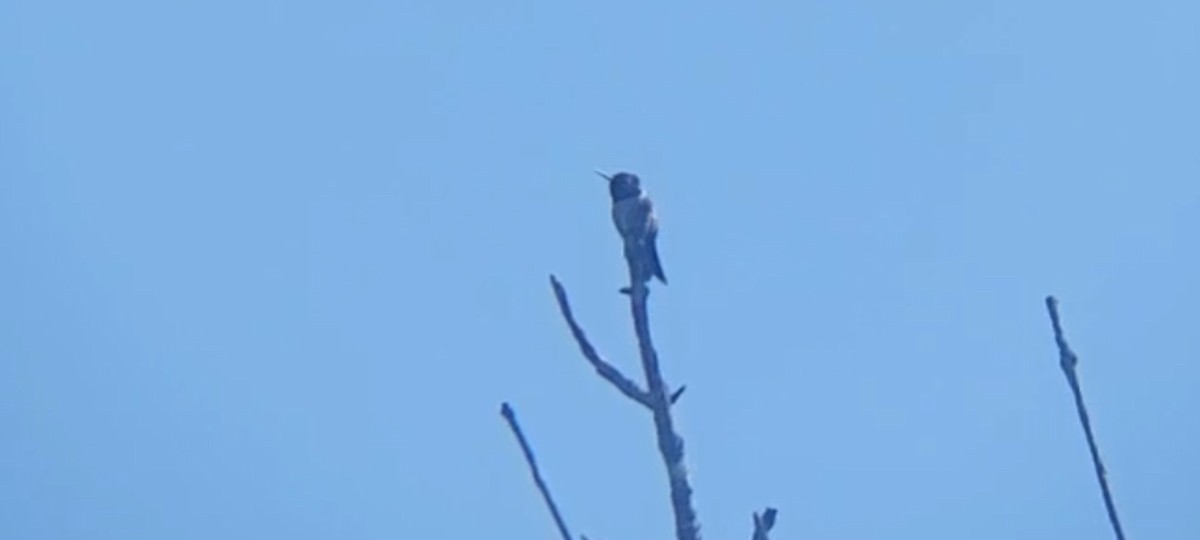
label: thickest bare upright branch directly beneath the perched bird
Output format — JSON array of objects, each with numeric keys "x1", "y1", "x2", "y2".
[{"x1": 626, "y1": 274, "x2": 700, "y2": 540}]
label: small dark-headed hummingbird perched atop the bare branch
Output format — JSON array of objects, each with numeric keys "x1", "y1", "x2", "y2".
[{"x1": 596, "y1": 170, "x2": 667, "y2": 284}]
